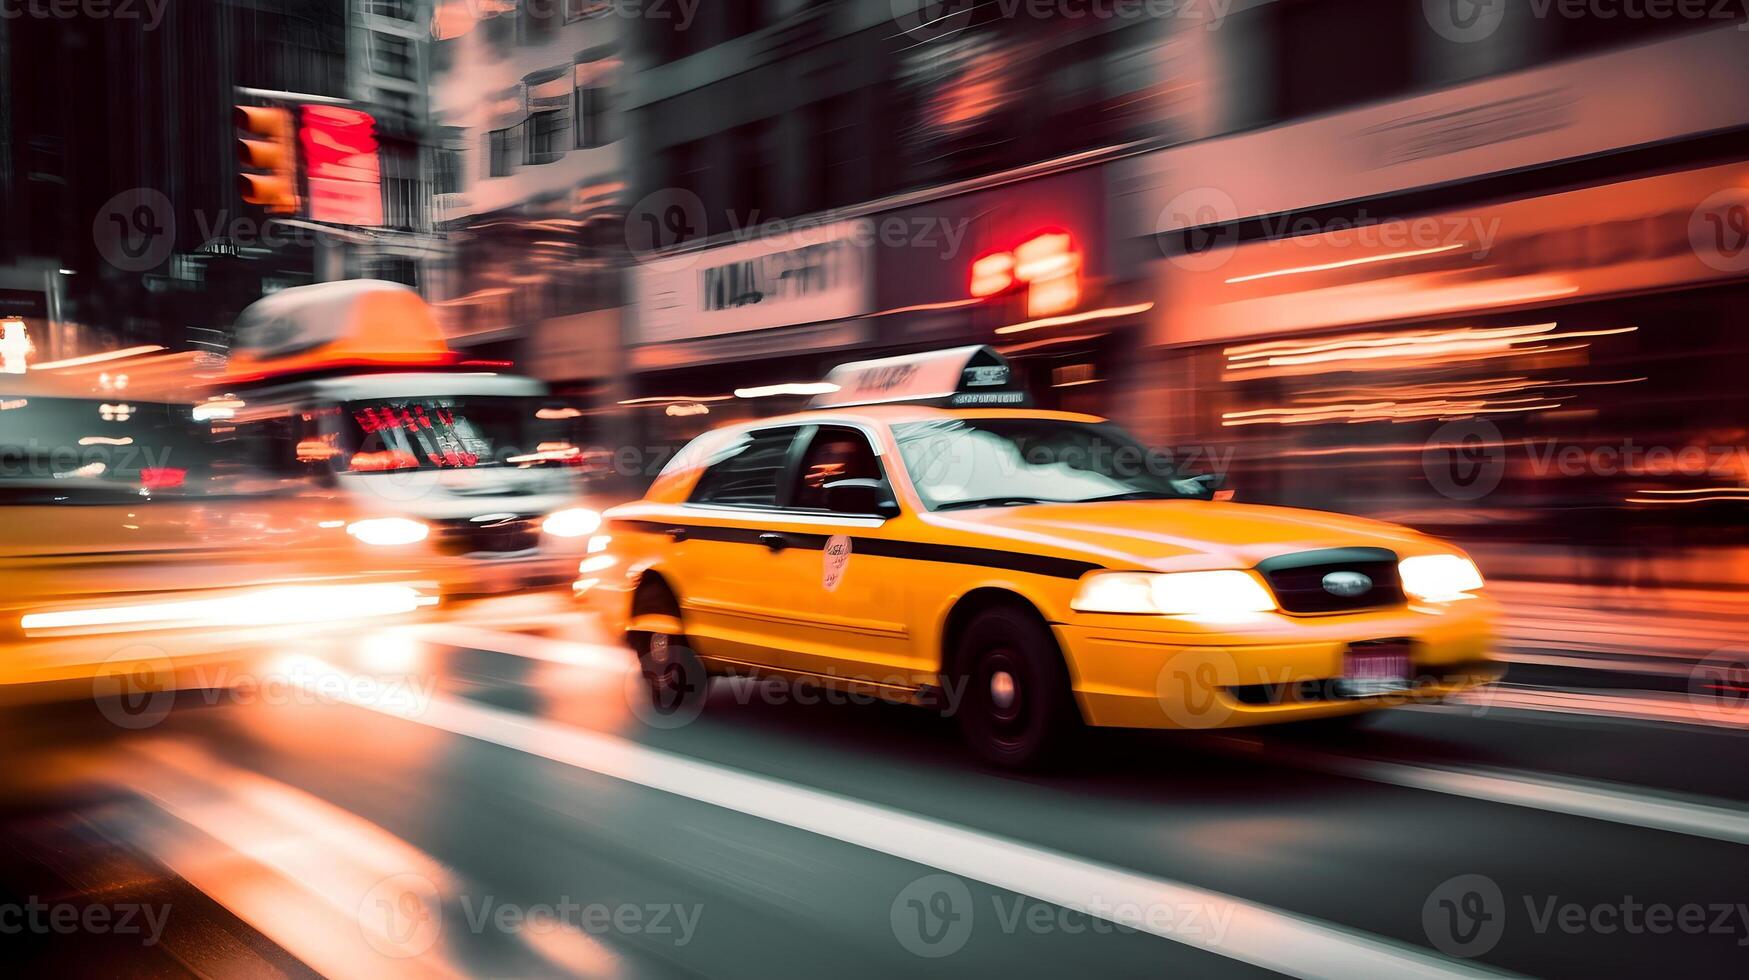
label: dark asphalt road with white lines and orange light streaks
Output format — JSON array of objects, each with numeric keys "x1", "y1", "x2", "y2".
[{"x1": 0, "y1": 599, "x2": 1749, "y2": 978}]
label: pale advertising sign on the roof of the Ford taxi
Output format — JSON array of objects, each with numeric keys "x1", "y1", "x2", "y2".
[{"x1": 808, "y1": 345, "x2": 1032, "y2": 408}]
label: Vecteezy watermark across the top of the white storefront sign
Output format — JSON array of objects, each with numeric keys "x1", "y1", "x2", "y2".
[{"x1": 626, "y1": 187, "x2": 971, "y2": 270}]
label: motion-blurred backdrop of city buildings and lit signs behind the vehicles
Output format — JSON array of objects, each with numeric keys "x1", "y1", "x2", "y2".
[{"x1": 0, "y1": 0, "x2": 1749, "y2": 686}]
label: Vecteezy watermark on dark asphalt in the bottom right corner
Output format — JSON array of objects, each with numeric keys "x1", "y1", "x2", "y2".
[{"x1": 1422, "y1": 875, "x2": 1749, "y2": 957}]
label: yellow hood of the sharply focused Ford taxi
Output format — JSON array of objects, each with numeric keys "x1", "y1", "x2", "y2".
[{"x1": 923, "y1": 501, "x2": 1450, "y2": 572}]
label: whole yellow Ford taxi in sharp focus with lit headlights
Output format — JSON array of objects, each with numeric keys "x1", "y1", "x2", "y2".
[{"x1": 574, "y1": 347, "x2": 1501, "y2": 767}]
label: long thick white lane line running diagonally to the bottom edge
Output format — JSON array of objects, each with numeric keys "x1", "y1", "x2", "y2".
[{"x1": 325, "y1": 668, "x2": 1502, "y2": 980}]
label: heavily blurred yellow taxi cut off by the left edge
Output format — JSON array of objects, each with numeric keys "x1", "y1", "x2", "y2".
[{"x1": 0, "y1": 365, "x2": 437, "y2": 702}]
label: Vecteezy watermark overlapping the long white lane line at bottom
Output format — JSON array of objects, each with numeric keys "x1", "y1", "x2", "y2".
[{"x1": 888, "y1": 873, "x2": 1235, "y2": 959}]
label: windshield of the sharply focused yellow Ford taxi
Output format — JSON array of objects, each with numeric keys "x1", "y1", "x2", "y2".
[{"x1": 892, "y1": 418, "x2": 1209, "y2": 511}]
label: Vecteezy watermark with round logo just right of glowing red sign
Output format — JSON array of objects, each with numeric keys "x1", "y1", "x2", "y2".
[{"x1": 1154, "y1": 187, "x2": 1501, "y2": 273}]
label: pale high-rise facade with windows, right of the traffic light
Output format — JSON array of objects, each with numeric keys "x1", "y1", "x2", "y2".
[{"x1": 430, "y1": 0, "x2": 626, "y2": 413}]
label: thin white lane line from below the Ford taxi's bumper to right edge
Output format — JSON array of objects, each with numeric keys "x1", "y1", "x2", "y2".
[{"x1": 1266, "y1": 747, "x2": 1749, "y2": 844}]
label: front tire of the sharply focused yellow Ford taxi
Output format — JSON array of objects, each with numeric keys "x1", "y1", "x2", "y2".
[{"x1": 955, "y1": 606, "x2": 1081, "y2": 768}]
